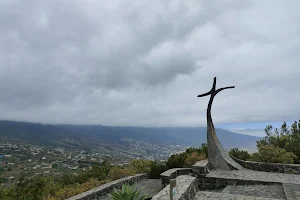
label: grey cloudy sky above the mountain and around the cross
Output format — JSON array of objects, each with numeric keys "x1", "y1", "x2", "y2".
[{"x1": 0, "y1": 0, "x2": 300, "y2": 136}]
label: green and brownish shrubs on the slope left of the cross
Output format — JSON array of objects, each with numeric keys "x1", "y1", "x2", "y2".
[{"x1": 0, "y1": 144, "x2": 207, "y2": 200}]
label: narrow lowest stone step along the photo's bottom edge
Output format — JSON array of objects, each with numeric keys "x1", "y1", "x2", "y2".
[{"x1": 194, "y1": 191, "x2": 280, "y2": 200}]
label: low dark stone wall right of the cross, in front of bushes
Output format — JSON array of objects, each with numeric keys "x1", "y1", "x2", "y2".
[{"x1": 231, "y1": 156, "x2": 300, "y2": 174}]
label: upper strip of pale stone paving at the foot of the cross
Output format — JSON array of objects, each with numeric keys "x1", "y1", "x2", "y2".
[{"x1": 206, "y1": 170, "x2": 300, "y2": 184}]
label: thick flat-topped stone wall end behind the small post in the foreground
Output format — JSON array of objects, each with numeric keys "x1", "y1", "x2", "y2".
[{"x1": 152, "y1": 175, "x2": 197, "y2": 200}]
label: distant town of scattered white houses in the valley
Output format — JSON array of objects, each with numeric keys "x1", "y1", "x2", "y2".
[{"x1": 0, "y1": 139, "x2": 188, "y2": 185}]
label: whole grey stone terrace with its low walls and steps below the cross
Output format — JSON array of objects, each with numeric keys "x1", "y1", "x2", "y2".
[{"x1": 69, "y1": 160, "x2": 300, "y2": 200}]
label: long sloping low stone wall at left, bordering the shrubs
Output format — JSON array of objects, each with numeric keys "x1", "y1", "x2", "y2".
[{"x1": 67, "y1": 174, "x2": 148, "y2": 200}]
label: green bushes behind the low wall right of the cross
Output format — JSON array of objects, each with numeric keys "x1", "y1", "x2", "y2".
[{"x1": 229, "y1": 120, "x2": 300, "y2": 164}]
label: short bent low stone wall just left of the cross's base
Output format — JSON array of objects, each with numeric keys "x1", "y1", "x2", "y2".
[{"x1": 160, "y1": 168, "x2": 193, "y2": 187}]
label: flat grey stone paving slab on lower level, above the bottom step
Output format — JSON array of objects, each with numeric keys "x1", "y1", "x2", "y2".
[{"x1": 222, "y1": 184, "x2": 285, "y2": 199}]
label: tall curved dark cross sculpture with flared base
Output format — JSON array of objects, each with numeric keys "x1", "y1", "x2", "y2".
[{"x1": 198, "y1": 77, "x2": 242, "y2": 170}]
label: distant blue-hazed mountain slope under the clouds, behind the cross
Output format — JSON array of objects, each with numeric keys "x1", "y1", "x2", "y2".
[{"x1": 0, "y1": 120, "x2": 259, "y2": 150}]
